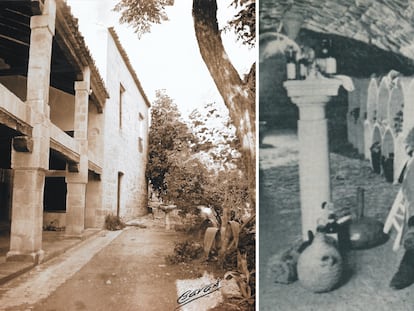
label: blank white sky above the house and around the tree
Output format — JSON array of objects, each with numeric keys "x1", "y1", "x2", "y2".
[{"x1": 66, "y1": 0, "x2": 256, "y2": 116}]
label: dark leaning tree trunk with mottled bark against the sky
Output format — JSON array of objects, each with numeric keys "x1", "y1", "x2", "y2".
[{"x1": 193, "y1": 0, "x2": 256, "y2": 210}]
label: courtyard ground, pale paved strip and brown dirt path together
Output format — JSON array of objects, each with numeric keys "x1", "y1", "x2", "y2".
[{"x1": 0, "y1": 222, "x2": 223, "y2": 311}]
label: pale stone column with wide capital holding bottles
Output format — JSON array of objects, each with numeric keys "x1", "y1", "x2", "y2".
[{"x1": 284, "y1": 78, "x2": 341, "y2": 240}]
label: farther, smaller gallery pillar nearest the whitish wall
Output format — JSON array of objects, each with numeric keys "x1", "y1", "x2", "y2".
[{"x1": 66, "y1": 68, "x2": 90, "y2": 237}]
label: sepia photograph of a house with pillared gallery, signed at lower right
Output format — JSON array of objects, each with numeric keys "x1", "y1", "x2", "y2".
[{"x1": 0, "y1": 0, "x2": 258, "y2": 311}]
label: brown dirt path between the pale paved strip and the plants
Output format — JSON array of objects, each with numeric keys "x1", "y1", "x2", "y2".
[{"x1": 34, "y1": 228, "x2": 186, "y2": 311}]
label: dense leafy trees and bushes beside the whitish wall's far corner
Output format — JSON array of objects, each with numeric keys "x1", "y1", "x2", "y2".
[{"x1": 146, "y1": 91, "x2": 248, "y2": 219}]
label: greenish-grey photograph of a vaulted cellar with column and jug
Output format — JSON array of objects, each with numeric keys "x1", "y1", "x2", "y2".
[{"x1": 258, "y1": 0, "x2": 414, "y2": 311}]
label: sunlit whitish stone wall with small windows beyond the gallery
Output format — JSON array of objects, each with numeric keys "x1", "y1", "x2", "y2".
[{"x1": 96, "y1": 30, "x2": 148, "y2": 224}]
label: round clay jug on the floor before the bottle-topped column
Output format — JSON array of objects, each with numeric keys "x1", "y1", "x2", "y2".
[{"x1": 297, "y1": 232, "x2": 343, "y2": 293}]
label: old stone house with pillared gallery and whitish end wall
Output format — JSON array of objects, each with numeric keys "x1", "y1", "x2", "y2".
[{"x1": 0, "y1": 0, "x2": 150, "y2": 262}]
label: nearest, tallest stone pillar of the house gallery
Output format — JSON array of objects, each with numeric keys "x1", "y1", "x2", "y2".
[{"x1": 6, "y1": 0, "x2": 56, "y2": 263}]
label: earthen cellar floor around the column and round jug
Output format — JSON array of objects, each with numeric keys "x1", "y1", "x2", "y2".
[{"x1": 259, "y1": 131, "x2": 414, "y2": 311}]
